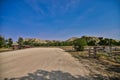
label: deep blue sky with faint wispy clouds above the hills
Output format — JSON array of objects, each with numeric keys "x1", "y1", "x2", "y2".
[{"x1": 0, "y1": 0, "x2": 120, "y2": 40}]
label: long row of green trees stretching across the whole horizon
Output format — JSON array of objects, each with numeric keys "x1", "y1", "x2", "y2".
[{"x1": 0, "y1": 36, "x2": 120, "y2": 51}]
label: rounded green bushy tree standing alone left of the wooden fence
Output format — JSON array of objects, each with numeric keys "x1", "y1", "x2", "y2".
[{"x1": 73, "y1": 38, "x2": 87, "y2": 51}]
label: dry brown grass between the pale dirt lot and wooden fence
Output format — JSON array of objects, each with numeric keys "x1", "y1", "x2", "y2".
[{"x1": 61, "y1": 46, "x2": 120, "y2": 80}]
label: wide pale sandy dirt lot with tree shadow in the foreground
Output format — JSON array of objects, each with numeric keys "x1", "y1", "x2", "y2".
[{"x1": 0, "y1": 48, "x2": 90, "y2": 80}]
